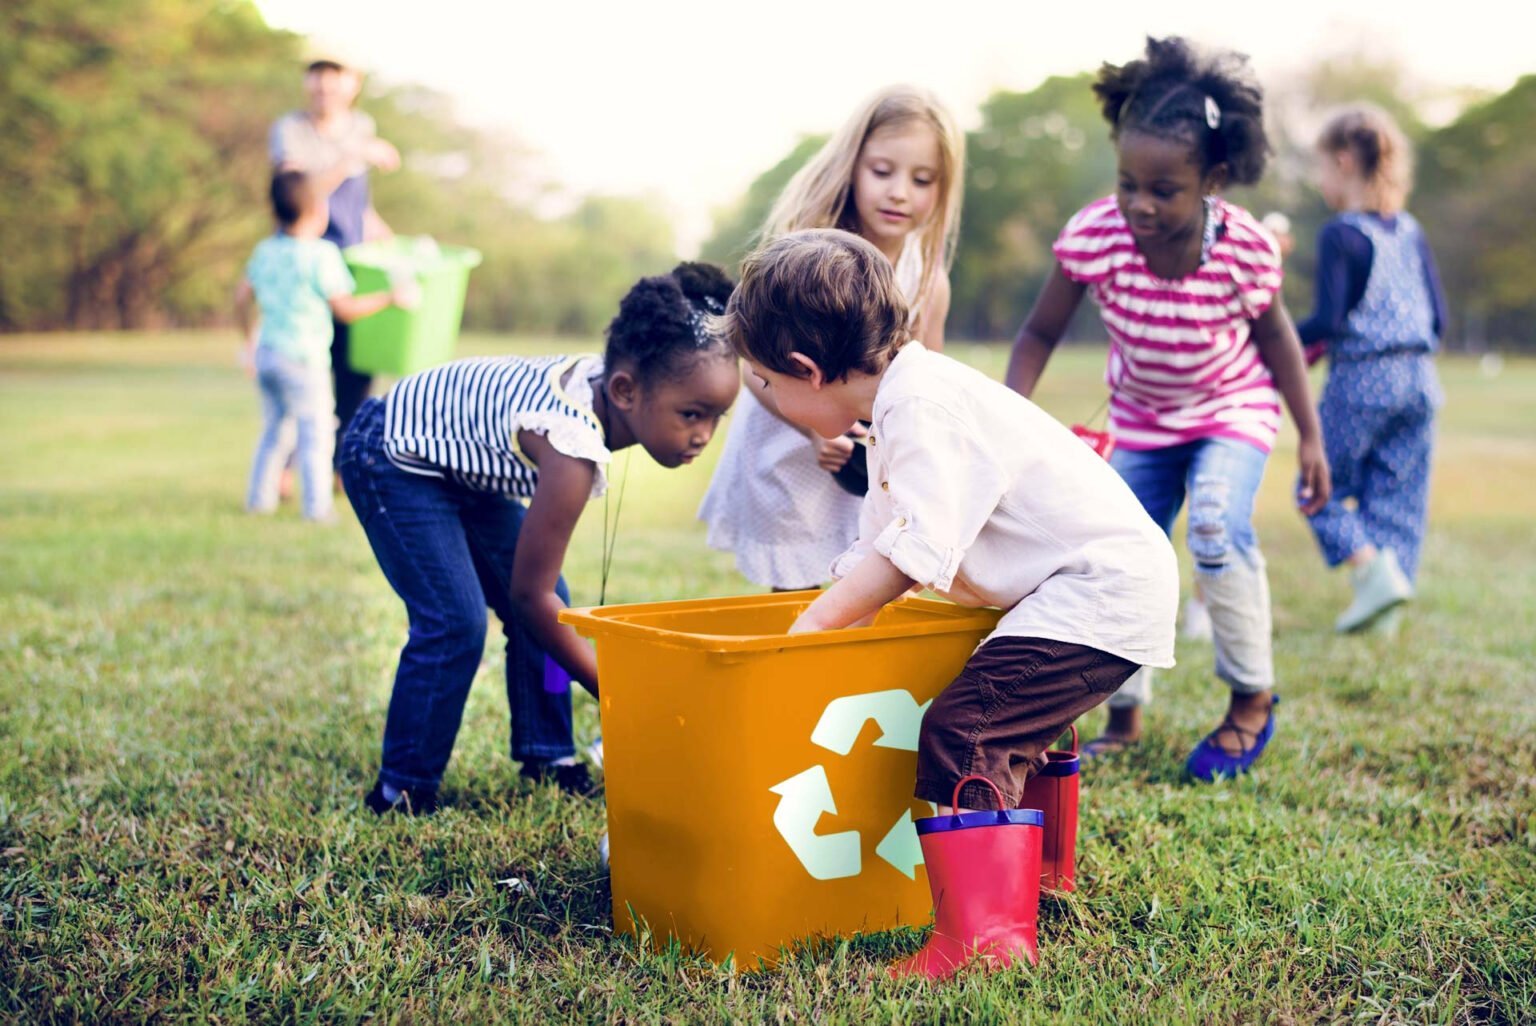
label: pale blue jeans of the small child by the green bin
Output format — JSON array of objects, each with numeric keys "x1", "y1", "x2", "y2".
[{"x1": 246, "y1": 346, "x2": 335, "y2": 521}]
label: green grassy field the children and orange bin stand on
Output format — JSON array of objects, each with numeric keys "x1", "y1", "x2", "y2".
[{"x1": 0, "y1": 335, "x2": 1536, "y2": 1023}]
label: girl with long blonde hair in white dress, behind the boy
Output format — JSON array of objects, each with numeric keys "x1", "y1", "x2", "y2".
[{"x1": 699, "y1": 86, "x2": 965, "y2": 590}]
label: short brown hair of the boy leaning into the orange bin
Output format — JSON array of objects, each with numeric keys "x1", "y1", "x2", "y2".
[{"x1": 719, "y1": 229, "x2": 911, "y2": 381}]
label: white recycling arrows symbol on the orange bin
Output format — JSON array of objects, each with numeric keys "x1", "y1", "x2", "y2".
[{"x1": 768, "y1": 688, "x2": 931, "y2": 880}]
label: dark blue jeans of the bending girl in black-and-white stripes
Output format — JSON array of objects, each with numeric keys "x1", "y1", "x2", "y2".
[{"x1": 338, "y1": 399, "x2": 576, "y2": 788}]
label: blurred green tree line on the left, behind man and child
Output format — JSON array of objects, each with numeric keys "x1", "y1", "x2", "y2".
[{"x1": 0, "y1": 0, "x2": 676, "y2": 335}]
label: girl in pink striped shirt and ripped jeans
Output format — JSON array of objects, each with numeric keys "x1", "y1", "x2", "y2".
[{"x1": 1008, "y1": 37, "x2": 1329, "y2": 780}]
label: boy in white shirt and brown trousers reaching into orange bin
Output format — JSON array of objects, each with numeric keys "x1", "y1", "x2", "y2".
[{"x1": 722, "y1": 229, "x2": 1178, "y2": 814}]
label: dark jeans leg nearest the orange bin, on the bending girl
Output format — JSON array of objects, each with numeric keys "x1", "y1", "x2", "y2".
[{"x1": 464, "y1": 495, "x2": 576, "y2": 762}]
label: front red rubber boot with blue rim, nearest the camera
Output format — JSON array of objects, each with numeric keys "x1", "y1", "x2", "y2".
[{"x1": 891, "y1": 777, "x2": 1043, "y2": 980}]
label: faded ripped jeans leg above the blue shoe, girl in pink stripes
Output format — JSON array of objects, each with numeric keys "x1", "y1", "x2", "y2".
[{"x1": 1187, "y1": 438, "x2": 1275, "y2": 694}]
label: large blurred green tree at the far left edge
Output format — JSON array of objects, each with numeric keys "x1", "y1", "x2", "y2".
[{"x1": 0, "y1": 0, "x2": 298, "y2": 329}]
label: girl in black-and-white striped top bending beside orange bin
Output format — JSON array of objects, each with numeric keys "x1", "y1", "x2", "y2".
[{"x1": 338, "y1": 264, "x2": 740, "y2": 814}]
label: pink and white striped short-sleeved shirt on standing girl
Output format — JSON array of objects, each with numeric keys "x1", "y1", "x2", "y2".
[{"x1": 1052, "y1": 197, "x2": 1281, "y2": 452}]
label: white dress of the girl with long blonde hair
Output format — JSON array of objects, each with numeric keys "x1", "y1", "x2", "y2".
[{"x1": 699, "y1": 235, "x2": 923, "y2": 588}]
